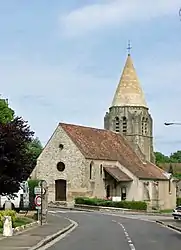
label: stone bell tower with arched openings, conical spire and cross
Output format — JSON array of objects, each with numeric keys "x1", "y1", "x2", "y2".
[{"x1": 104, "y1": 45, "x2": 155, "y2": 163}]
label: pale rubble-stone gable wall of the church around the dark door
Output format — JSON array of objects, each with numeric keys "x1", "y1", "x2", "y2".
[{"x1": 31, "y1": 126, "x2": 88, "y2": 202}]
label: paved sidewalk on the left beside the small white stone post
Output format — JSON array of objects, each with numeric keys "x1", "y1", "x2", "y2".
[{"x1": 0, "y1": 215, "x2": 71, "y2": 250}]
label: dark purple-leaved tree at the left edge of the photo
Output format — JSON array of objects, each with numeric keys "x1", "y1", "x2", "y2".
[{"x1": 0, "y1": 117, "x2": 35, "y2": 195}]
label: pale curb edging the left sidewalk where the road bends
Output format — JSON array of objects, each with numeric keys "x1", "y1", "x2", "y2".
[{"x1": 29, "y1": 218, "x2": 77, "y2": 250}]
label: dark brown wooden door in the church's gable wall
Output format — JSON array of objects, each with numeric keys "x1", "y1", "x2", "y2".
[{"x1": 55, "y1": 179, "x2": 67, "y2": 201}]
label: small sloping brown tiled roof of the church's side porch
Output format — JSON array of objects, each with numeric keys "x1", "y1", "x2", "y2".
[{"x1": 104, "y1": 166, "x2": 132, "y2": 182}]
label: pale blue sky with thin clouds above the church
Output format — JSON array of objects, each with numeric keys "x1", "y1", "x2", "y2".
[{"x1": 0, "y1": 0, "x2": 181, "y2": 155}]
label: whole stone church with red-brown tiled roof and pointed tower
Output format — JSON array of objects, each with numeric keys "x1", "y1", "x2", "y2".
[{"x1": 31, "y1": 50, "x2": 176, "y2": 210}]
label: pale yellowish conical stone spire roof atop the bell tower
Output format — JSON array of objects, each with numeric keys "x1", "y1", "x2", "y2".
[{"x1": 112, "y1": 55, "x2": 147, "y2": 108}]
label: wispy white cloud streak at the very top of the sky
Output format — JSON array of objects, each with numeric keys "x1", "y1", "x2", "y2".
[{"x1": 60, "y1": 0, "x2": 181, "y2": 36}]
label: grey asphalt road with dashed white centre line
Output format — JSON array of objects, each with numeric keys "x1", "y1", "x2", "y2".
[{"x1": 42, "y1": 210, "x2": 181, "y2": 250}]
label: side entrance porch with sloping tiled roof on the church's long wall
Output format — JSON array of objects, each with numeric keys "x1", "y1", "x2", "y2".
[{"x1": 104, "y1": 166, "x2": 132, "y2": 201}]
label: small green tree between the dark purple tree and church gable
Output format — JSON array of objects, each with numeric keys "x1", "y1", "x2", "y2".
[{"x1": 28, "y1": 137, "x2": 43, "y2": 165}]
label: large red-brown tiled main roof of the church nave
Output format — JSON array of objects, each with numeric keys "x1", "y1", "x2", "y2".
[{"x1": 60, "y1": 123, "x2": 167, "y2": 180}]
